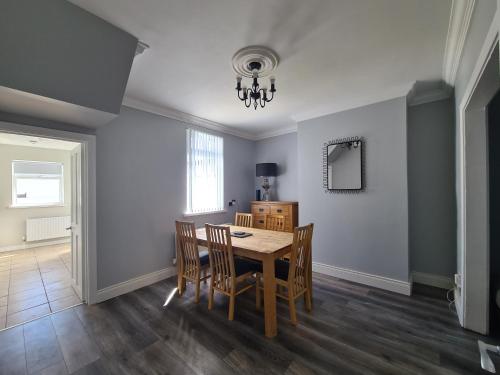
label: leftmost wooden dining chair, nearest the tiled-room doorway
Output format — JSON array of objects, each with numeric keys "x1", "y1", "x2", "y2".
[{"x1": 175, "y1": 220, "x2": 210, "y2": 303}]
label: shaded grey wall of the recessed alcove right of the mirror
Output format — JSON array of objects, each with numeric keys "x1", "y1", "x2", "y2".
[{"x1": 408, "y1": 98, "x2": 456, "y2": 277}]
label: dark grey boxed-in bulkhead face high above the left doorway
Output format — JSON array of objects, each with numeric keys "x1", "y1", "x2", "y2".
[{"x1": 0, "y1": 0, "x2": 137, "y2": 113}]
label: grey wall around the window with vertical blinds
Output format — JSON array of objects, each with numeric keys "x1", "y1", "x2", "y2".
[{"x1": 97, "y1": 107, "x2": 255, "y2": 289}]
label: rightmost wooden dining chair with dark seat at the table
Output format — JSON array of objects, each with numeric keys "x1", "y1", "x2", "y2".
[{"x1": 256, "y1": 223, "x2": 314, "y2": 325}]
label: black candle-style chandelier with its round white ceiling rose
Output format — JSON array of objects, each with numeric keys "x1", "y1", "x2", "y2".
[{"x1": 233, "y1": 46, "x2": 279, "y2": 109}]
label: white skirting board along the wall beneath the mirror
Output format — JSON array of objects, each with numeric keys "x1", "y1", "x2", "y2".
[{"x1": 313, "y1": 262, "x2": 411, "y2": 296}]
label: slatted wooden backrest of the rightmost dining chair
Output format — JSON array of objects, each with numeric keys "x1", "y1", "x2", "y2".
[{"x1": 288, "y1": 224, "x2": 314, "y2": 295}]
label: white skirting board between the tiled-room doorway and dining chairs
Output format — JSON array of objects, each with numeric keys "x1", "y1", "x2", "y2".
[{"x1": 96, "y1": 267, "x2": 177, "y2": 303}]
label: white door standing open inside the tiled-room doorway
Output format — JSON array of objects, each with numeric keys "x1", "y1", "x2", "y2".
[{"x1": 71, "y1": 145, "x2": 83, "y2": 299}]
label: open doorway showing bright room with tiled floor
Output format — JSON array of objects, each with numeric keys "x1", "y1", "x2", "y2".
[{"x1": 0, "y1": 132, "x2": 83, "y2": 329}]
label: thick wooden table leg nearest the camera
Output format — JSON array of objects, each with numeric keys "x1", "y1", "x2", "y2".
[{"x1": 262, "y1": 255, "x2": 278, "y2": 337}]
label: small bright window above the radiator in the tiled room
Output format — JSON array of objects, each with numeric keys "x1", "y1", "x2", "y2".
[{"x1": 12, "y1": 160, "x2": 64, "y2": 207}]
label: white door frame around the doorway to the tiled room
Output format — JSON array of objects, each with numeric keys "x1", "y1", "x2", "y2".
[{"x1": 0, "y1": 121, "x2": 97, "y2": 304}]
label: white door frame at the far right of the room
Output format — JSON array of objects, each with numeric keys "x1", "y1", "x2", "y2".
[{"x1": 455, "y1": 0, "x2": 500, "y2": 334}]
